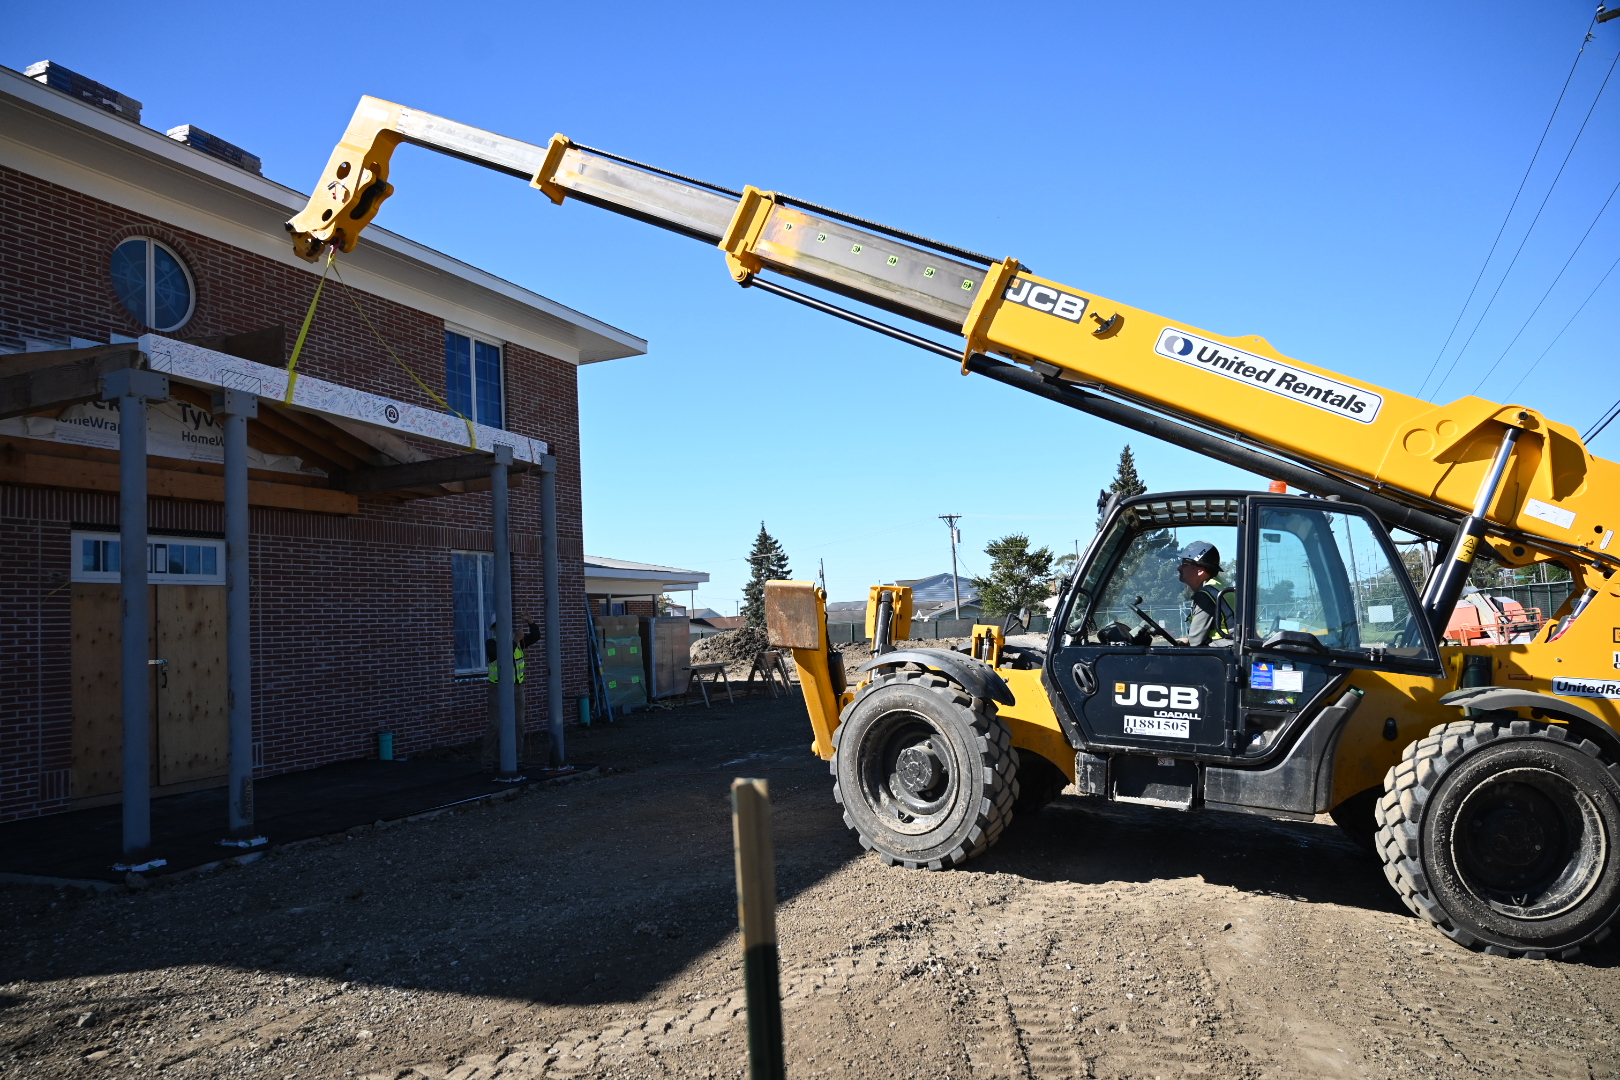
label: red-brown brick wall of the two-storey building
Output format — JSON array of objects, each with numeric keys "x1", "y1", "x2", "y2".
[{"x1": 0, "y1": 167, "x2": 588, "y2": 821}]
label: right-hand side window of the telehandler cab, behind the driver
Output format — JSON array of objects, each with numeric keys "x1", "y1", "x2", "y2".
[{"x1": 1251, "y1": 505, "x2": 1427, "y2": 656}]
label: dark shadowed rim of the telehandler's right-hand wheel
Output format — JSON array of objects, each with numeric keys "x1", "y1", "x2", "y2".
[{"x1": 1452, "y1": 767, "x2": 1609, "y2": 918}]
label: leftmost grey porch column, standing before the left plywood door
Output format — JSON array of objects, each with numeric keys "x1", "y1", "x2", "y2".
[{"x1": 102, "y1": 368, "x2": 168, "y2": 861}]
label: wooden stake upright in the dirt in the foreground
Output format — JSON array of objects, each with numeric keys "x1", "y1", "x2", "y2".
[{"x1": 731, "y1": 777, "x2": 787, "y2": 1080}]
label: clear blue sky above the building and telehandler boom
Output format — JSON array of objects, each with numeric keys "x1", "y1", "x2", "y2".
[{"x1": 9, "y1": 0, "x2": 1620, "y2": 612}]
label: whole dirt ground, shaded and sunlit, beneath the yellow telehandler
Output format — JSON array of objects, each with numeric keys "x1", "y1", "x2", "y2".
[{"x1": 0, "y1": 699, "x2": 1620, "y2": 1080}]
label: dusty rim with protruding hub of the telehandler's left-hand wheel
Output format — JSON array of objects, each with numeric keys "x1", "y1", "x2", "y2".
[{"x1": 857, "y1": 709, "x2": 959, "y2": 836}]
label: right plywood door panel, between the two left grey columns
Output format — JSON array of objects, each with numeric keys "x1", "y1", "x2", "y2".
[{"x1": 152, "y1": 585, "x2": 230, "y2": 784}]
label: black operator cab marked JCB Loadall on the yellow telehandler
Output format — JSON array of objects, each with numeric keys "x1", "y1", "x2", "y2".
[{"x1": 1047, "y1": 491, "x2": 1440, "y2": 805}]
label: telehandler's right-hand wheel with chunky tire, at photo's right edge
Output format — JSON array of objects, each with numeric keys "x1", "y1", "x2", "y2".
[{"x1": 1377, "y1": 716, "x2": 1620, "y2": 959}]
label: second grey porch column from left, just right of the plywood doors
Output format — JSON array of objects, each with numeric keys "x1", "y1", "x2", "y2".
[{"x1": 214, "y1": 390, "x2": 259, "y2": 840}]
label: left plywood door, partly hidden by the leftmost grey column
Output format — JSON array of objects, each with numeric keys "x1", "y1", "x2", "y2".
[{"x1": 71, "y1": 583, "x2": 159, "y2": 798}]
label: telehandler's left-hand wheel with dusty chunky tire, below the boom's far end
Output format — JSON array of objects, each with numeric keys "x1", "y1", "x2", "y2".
[{"x1": 831, "y1": 670, "x2": 1017, "y2": 870}]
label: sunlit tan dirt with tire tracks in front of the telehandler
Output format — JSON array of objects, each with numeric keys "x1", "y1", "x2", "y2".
[{"x1": 369, "y1": 858, "x2": 1620, "y2": 1080}]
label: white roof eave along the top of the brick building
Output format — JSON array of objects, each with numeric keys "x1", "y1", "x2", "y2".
[{"x1": 0, "y1": 66, "x2": 646, "y2": 364}]
